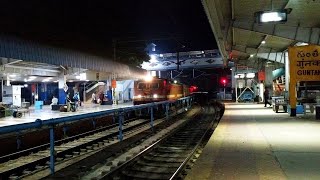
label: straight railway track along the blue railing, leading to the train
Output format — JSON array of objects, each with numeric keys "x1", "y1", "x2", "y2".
[{"x1": 0, "y1": 116, "x2": 162, "y2": 179}]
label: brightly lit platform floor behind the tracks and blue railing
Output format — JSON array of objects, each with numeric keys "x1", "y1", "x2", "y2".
[{"x1": 0, "y1": 102, "x2": 133, "y2": 127}]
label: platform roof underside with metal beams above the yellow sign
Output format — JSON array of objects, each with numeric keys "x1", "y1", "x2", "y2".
[{"x1": 202, "y1": 0, "x2": 320, "y2": 70}]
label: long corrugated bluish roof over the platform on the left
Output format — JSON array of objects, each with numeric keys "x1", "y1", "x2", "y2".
[{"x1": 0, "y1": 35, "x2": 145, "y2": 82}]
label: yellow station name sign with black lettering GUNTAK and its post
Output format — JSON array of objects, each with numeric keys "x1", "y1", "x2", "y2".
[{"x1": 289, "y1": 45, "x2": 320, "y2": 116}]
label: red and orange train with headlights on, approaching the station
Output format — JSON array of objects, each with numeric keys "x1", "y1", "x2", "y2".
[{"x1": 133, "y1": 77, "x2": 194, "y2": 105}]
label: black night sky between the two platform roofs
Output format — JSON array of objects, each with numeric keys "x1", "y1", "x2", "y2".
[{"x1": 0, "y1": 0, "x2": 216, "y2": 55}]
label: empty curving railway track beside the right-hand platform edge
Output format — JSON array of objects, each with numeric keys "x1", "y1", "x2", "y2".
[{"x1": 86, "y1": 107, "x2": 216, "y2": 179}]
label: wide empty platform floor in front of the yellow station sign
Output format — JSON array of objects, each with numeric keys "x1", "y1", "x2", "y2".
[{"x1": 186, "y1": 103, "x2": 320, "y2": 180}]
